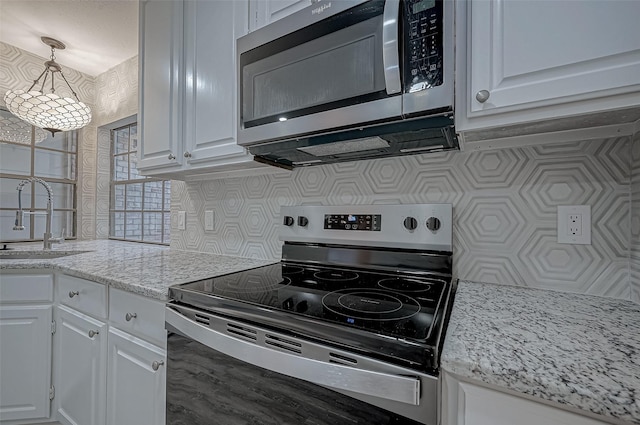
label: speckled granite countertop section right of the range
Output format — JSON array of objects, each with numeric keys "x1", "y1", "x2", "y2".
[{"x1": 442, "y1": 281, "x2": 640, "y2": 424}]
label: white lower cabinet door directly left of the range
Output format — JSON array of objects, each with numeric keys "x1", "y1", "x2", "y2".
[{"x1": 107, "y1": 327, "x2": 166, "y2": 425}]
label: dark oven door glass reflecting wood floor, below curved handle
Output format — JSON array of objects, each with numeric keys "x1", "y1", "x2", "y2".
[{"x1": 167, "y1": 333, "x2": 421, "y2": 425}]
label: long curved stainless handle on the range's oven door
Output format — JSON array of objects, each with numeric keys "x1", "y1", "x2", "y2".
[{"x1": 165, "y1": 308, "x2": 420, "y2": 406}]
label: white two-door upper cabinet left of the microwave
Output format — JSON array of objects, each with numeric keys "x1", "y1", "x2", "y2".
[{"x1": 138, "y1": 0, "x2": 280, "y2": 179}]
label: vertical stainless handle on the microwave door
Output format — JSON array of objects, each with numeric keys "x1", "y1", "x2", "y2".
[{"x1": 382, "y1": 0, "x2": 401, "y2": 94}]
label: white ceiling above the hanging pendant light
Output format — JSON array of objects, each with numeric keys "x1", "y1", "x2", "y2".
[{"x1": 0, "y1": 0, "x2": 138, "y2": 76}]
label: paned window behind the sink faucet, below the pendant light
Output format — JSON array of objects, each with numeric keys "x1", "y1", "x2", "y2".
[{"x1": 0, "y1": 109, "x2": 78, "y2": 242}]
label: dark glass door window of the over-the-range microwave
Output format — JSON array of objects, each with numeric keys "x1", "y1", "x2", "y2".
[{"x1": 240, "y1": 2, "x2": 387, "y2": 128}]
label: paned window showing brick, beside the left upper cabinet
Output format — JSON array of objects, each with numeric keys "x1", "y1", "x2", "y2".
[{"x1": 109, "y1": 124, "x2": 171, "y2": 245}]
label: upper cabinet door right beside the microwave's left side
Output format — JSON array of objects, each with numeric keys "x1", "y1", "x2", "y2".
[{"x1": 184, "y1": 0, "x2": 252, "y2": 166}]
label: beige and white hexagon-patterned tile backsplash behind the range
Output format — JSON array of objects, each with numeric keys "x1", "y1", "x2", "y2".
[{"x1": 171, "y1": 137, "x2": 640, "y2": 299}]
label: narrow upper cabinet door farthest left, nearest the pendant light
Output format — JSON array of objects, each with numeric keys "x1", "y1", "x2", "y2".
[{"x1": 138, "y1": 0, "x2": 183, "y2": 170}]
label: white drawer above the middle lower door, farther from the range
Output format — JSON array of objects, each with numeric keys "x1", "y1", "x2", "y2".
[{"x1": 56, "y1": 275, "x2": 107, "y2": 319}]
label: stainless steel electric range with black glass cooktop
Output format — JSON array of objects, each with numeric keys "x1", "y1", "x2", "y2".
[{"x1": 166, "y1": 204, "x2": 456, "y2": 425}]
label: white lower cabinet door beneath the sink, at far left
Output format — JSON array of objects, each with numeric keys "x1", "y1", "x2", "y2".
[{"x1": 0, "y1": 305, "x2": 53, "y2": 421}]
